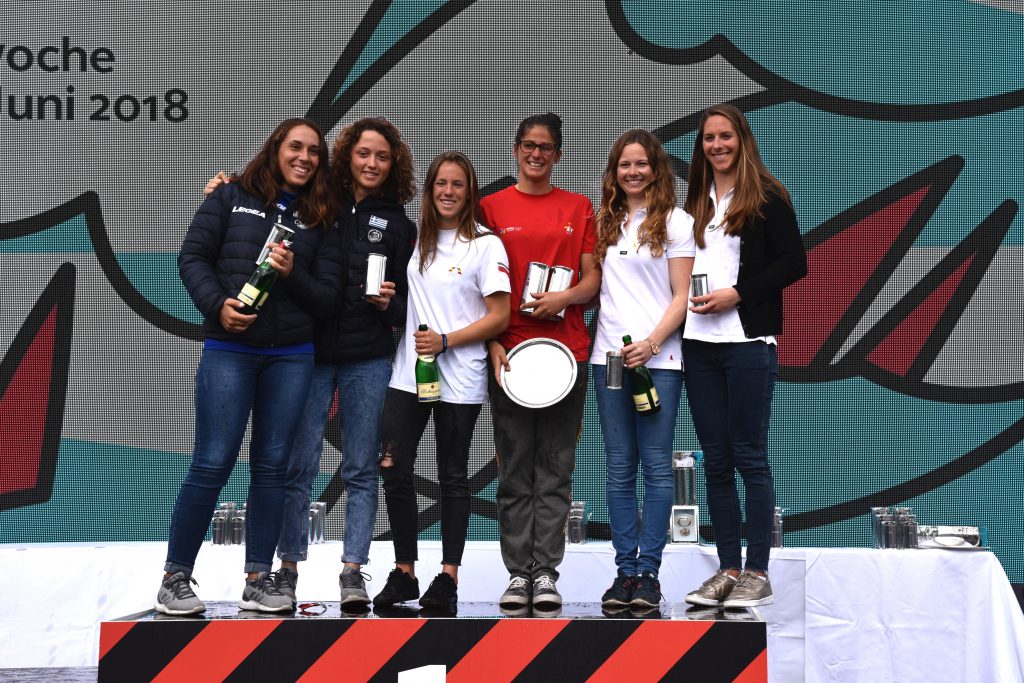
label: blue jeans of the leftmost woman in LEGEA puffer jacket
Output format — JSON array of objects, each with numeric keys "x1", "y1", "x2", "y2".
[{"x1": 164, "y1": 350, "x2": 313, "y2": 574}]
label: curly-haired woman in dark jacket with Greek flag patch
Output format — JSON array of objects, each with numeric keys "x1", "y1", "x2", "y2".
[{"x1": 278, "y1": 117, "x2": 416, "y2": 609}]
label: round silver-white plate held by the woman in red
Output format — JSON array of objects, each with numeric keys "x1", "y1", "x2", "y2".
[{"x1": 501, "y1": 337, "x2": 577, "y2": 408}]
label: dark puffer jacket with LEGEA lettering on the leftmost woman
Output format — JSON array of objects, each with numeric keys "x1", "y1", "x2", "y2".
[{"x1": 178, "y1": 182, "x2": 343, "y2": 346}]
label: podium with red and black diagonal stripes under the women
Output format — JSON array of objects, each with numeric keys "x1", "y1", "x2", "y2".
[{"x1": 98, "y1": 602, "x2": 768, "y2": 683}]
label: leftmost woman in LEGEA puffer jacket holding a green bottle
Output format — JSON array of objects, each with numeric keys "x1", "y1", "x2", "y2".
[{"x1": 156, "y1": 114, "x2": 341, "y2": 614}]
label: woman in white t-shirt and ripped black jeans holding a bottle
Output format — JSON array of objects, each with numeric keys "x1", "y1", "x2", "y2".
[{"x1": 374, "y1": 152, "x2": 510, "y2": 610}]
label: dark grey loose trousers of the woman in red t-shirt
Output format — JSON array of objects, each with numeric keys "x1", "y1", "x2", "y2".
[{"x1": 487, "y1": 362, "x2": 588, "y2": 580}]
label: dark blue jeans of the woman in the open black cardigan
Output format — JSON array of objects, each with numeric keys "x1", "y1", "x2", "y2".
[{"x1": 683, "y1": 339, "x2": 778, "y2": 571}]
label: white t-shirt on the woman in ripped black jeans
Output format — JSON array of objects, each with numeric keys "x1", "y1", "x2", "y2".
[{"x1": 390, "y1": 226, "x2": 511, "y2": 403}]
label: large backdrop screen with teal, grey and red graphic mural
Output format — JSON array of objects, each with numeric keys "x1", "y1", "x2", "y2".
[{"x1": 0, "y1": 0, "x2": 1024, "y2": 583}]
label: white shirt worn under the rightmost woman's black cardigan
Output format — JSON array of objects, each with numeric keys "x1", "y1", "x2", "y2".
[{"x1": 683, "y1": 183, "x2": 775, "y2": 344}]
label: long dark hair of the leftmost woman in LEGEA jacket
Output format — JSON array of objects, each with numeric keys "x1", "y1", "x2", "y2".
[{"x1": 239, "y1": 118, "x2": 338, "y2": 227}]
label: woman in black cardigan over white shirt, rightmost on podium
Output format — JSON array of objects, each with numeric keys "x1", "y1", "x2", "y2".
[{"x1": 683, "y1": 104, "x2": 807, "y2": 607}]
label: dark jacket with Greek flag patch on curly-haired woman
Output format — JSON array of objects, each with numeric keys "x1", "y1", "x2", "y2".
[{"x1": 316, "y1": 196, "x2": 416, "y2": 365}]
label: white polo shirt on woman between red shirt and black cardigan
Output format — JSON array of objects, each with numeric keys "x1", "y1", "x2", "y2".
[{"x1": 590, "y1": 208, "x2": 694, "y2": 370}]
